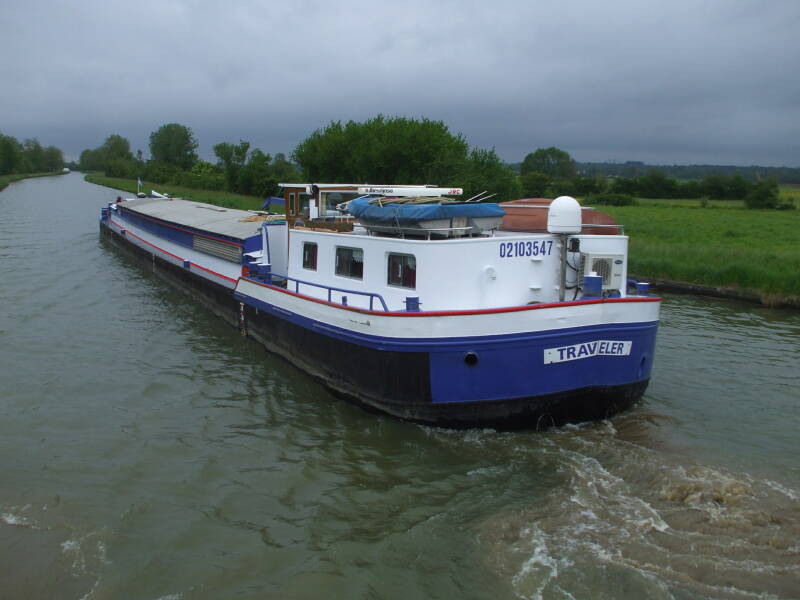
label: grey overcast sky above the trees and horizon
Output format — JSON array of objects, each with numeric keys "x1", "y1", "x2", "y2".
[{"x1": 0, "y1": 0, "x2": 800, "y2": 167}]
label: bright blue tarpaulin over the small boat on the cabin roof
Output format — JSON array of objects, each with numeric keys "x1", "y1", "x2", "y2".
[{"x1": 349, "y1": 197, "x2": 506, "y2": 225}]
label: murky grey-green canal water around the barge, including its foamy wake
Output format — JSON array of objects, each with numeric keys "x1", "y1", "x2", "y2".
[{"x1": 0, "y1": 174, "x2": 800, "y2": 600}]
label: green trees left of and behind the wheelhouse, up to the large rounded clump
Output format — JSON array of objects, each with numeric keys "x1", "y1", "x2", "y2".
[{"x1": 79, "y1": 115, "x2": 521, "y2": 201}]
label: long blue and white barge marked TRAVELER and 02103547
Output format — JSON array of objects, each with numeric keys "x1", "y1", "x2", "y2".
[{"x1": 100, "y1": 184, "x2": 661, "y2": 429}]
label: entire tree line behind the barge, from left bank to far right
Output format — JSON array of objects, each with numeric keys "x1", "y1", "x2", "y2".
[{"x1": 80, "y1": 115, "x2": 788, "y2": 208}]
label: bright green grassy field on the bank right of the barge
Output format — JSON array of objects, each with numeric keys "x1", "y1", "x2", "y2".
[{"x1": 600, "y1": 200, "x2": 800, "y2": 303}]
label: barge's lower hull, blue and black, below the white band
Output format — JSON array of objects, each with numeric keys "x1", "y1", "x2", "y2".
[{"x1": 101, "y1": 224, "x2": 658, "y2": 429}]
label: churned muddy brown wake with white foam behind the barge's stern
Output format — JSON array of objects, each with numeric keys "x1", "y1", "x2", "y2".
[{"x1": 479, "y1": 426, "x2": 800, "y2": 599}]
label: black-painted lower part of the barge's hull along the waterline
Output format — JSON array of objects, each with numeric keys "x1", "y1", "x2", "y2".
[{"x1": 101, "y1": 222, "x2": 649, "y2": 430}]
